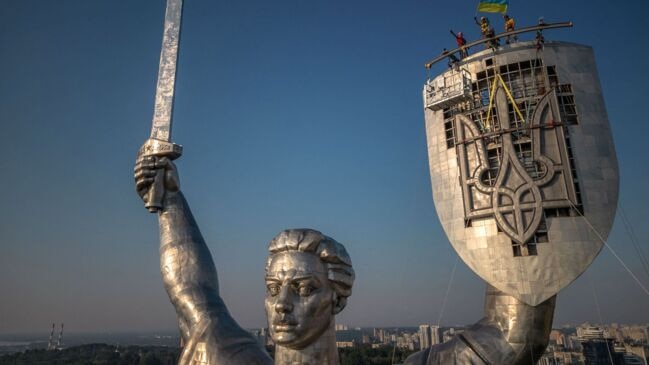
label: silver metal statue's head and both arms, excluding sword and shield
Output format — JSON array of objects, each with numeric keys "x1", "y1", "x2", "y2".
[{"x1": 135, "y1": 156, "x2": 555, "y2": 365}]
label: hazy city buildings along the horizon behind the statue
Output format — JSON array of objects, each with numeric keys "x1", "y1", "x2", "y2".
[{"x1": 0, "y1": 323, "x2": 649, "y2": 365}]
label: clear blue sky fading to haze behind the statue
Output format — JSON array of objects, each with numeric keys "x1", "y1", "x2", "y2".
[{"x1": 0, "y1": 0, "x2": 649, "y2": 334}]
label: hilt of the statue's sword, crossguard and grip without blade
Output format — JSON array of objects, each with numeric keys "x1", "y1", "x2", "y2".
[{"x1": 139, "y1": 138, "x2": 183, "y2": 213}]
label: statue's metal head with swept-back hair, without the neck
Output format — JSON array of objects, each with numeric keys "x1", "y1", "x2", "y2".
[{"x1": 265, "y1": 229, "x2": 354, "y2": 349}]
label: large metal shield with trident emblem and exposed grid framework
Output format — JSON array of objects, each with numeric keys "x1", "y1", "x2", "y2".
[{"x1": 424, "y1": 42, "x2": 618, "y2": 305}]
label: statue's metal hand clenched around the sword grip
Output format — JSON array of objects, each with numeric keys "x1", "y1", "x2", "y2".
[{"x1": 134, "y1": 155, "x2": 180, "y2": 202}]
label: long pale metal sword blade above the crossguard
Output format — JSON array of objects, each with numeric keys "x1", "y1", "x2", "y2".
[{"x1": 151, "y1": 0, "x2": 183, "y2": 141}]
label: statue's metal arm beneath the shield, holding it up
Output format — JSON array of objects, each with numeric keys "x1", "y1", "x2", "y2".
[{"x1": 404, "y1": 285, "x2": 556, "y2": 365}]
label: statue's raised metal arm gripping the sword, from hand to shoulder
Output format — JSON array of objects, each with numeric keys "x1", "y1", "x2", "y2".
[{"x1": 135, "y1": 156, "x2": 272, "y2": 365}]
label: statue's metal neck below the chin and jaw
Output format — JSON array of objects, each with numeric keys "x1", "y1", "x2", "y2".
[{"x1": 275, "y1": 321, "x2": 340, "y2": 365}]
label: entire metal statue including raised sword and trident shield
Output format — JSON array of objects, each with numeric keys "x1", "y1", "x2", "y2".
[{"x1": 135, "y1": 0, "x2": 618, "y2": 365}]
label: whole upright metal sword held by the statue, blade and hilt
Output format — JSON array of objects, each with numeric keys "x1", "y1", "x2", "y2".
[{"x1": 140, "y1": 0, "x2": 183, "y2": 213}]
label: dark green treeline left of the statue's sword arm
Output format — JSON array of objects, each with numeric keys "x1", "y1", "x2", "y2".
[{"x1": 0, "y1": 344, "x2": 180, "y2": 365}]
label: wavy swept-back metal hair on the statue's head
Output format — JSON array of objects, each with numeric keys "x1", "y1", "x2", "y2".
[{"x1": 266, "y1": 228, "x2": 355, "y2": 306}]
